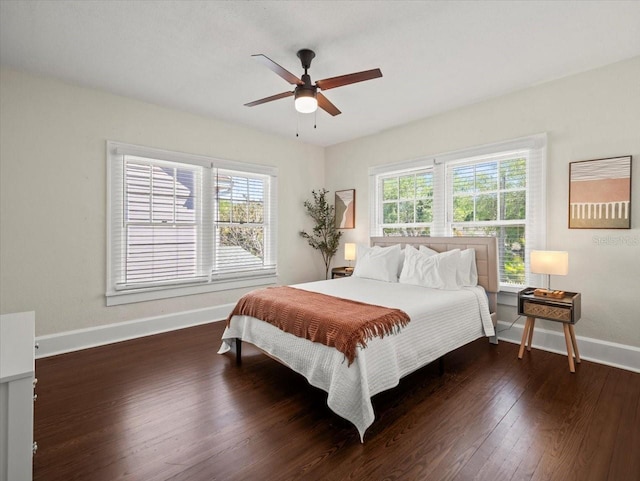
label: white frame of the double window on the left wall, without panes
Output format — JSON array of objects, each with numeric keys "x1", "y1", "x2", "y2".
[{"x1": 105, "y1": 141, "x2": 277, "y2": 306}]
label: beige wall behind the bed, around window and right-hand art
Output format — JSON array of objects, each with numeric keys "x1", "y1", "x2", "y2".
[{"x1": 325, "y1": 57, "x2": 640, "y2": 346}]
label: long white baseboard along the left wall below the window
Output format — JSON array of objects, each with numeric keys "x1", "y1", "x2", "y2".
[{"x1": 36, "y1": 304, "x2": 234, "y2": 359}]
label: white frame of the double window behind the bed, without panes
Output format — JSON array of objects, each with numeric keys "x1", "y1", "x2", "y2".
[{"x1": 369, "y1": 133, "x2": 547, "y2": 292}]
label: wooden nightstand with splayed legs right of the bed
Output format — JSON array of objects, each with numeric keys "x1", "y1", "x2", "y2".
[{"x1": 518, "y1": 287, "x2": 581, "y2": 372}]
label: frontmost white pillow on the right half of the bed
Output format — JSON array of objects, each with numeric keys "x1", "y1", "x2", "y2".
[{"x1": 399, "y1": 246, "x2": 460, "y2": 291}]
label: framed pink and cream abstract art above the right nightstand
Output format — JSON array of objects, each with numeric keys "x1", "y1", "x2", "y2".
[{"x1": 569, "y1": 155, "x2": 631, "y2": 229}]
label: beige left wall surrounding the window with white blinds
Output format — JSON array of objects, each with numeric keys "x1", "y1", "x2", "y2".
[{"x1": 0, "y1": 70, "x2": 324, "y2": 336}]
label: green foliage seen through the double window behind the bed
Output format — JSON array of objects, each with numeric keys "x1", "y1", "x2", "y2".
[{"x1": 381, "y1": 157, "x2": 527, "y2": 285}]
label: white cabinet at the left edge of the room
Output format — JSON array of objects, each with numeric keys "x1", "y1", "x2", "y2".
[{"x1": 0, "y1": 312, "x2": 35, "y2": 481}]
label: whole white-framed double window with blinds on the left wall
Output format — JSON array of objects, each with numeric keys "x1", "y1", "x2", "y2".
[{"x1": 107, "y1": 142, "x2": 276, "y2": 305}]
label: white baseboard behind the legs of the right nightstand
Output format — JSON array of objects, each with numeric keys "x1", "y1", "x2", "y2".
[{"x1": 497, "y1": 321, "x2": 640, "y2": 373}]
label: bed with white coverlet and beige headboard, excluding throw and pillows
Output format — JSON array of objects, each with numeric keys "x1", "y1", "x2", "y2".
[{"x1": 219, "y1": 237, "x2": 499, "y2": 441}]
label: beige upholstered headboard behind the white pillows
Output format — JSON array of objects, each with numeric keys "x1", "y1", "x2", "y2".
[{"x1": 371, "y1": 237, "x2": 500, "y2": 312}]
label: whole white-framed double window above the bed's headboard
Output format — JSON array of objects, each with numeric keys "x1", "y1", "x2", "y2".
[{"x1": 370, "y1": 135, "x2": 546, "y2": 290}]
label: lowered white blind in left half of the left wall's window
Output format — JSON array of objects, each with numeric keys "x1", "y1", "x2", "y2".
[{"x1": 122, "y1": 156, "x2": 205, "y2": 289}]
